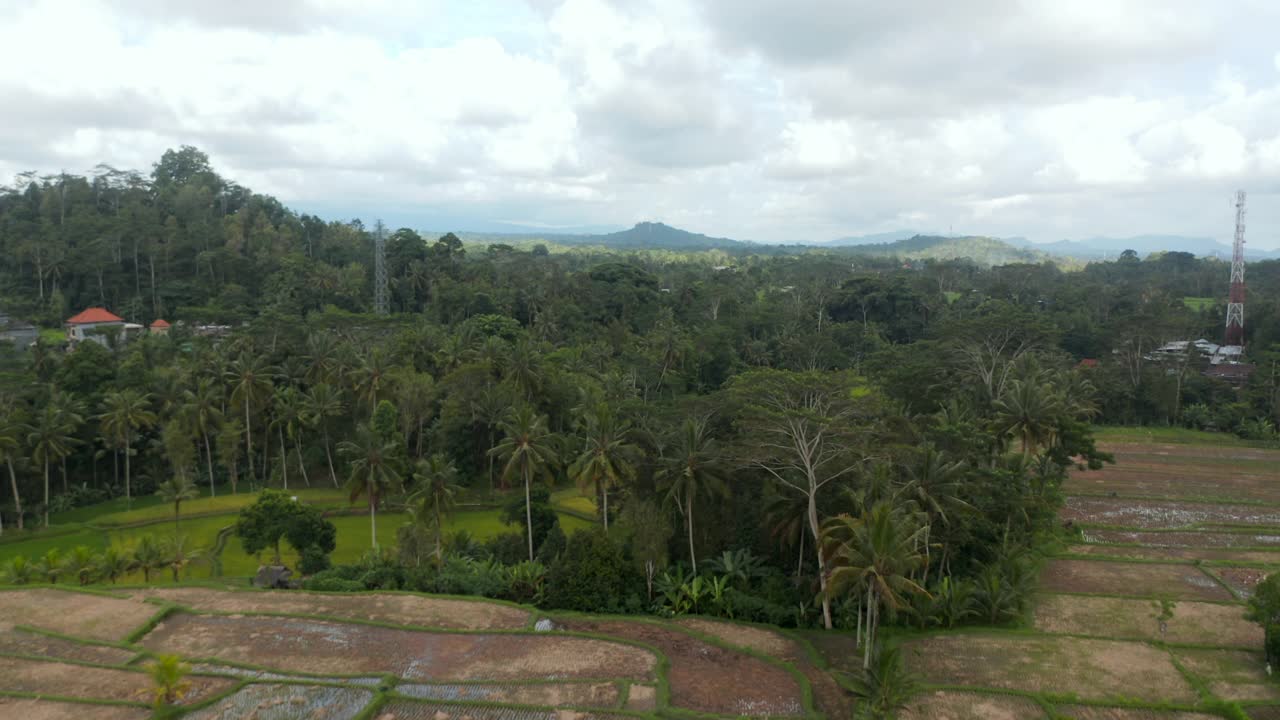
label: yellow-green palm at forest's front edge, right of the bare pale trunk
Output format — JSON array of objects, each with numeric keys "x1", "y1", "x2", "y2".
[{"x1": 822, "y1": 501, "x2": 928, "y2": 669}]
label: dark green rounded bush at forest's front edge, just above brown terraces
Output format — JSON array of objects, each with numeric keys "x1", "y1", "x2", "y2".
[{"x1": 544, "y1": 528, "x2": 628, "y2": 612}]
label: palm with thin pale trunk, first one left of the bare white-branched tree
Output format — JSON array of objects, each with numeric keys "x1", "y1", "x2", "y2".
[{"x1": 655, "y1": 418, "x2": 728, "y2": 575}]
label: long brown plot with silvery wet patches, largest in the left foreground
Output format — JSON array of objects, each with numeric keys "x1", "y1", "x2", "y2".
[{"x1": 142, "y1": 615, "x2": 655, "y2": 680}]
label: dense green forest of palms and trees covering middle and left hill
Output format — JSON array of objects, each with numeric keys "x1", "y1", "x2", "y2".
[{"x1": 0, "y1": 147, "x2": 1280, "y2": 632}]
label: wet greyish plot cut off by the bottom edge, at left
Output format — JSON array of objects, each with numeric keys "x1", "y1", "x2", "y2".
[{"x1": 186, "y1": 684, "x2": 374, "y2": 720}]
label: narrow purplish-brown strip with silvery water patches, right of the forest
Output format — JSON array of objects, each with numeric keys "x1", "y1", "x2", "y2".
[{"x1": 1060, "y1": 495, "x2": 1280, "y2": 529}]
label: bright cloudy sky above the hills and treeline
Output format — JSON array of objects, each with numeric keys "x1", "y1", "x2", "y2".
[{"x1": 0, "y1": 0, "x2": 1280, "y2": 249}]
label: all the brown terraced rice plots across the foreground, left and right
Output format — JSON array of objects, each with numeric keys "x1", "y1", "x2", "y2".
[{"x1": 0, "y1": 430, "x2": 1280, "y2": 720}]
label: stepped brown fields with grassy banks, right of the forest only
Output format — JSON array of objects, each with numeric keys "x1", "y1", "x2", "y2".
[{"x1": 885, "y1": 430, "x2": 1280, "y2": 720}]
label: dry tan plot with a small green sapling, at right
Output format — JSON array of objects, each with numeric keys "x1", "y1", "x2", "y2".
[{"x1": 1034, "y1": 594, "x2": 1262, "y2": 648}]
